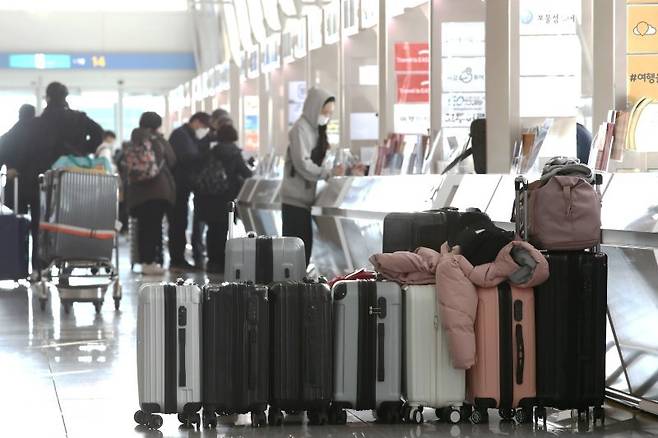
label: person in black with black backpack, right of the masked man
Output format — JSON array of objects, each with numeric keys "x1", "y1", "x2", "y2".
[{"x1": 194, "y1": 123, "x2": 252, "y2": 274}]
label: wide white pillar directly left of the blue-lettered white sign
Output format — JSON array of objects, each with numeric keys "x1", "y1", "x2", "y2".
[{"x1": 486, "y1": 0, "x2": 521, "y2": 173}]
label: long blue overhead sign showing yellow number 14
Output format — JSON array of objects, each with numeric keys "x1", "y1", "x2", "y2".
[{"x1": 0, "y1": 53, "x2": 196, "y2": 70}]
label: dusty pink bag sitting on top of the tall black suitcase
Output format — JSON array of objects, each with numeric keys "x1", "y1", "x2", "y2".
[{"x1": 528, "y1": 176, "x2": 601, "y2": 251}]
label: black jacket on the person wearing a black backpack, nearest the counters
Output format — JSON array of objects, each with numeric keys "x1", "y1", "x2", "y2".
[{"x1": 194, "y1": 143, "x2": 252, "y2": 222}]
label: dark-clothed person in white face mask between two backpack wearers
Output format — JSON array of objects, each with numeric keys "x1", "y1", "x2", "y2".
[{"x1": 167, "y1": 112, "x2": 210, "y2": 272}]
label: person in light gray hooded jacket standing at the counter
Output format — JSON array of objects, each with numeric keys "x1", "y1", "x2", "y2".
[{"x1": 281, "y1": 87, "x2": 344, "y2": 264}]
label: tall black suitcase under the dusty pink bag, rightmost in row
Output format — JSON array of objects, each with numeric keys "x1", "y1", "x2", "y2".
[{"x1": 535, "y1": 251, "x2": 608, "y2": 423}]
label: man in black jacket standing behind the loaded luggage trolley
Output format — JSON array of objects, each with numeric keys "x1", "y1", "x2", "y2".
[{"x1": 0, "y1": 82, "x2": 103, "y2": 267}]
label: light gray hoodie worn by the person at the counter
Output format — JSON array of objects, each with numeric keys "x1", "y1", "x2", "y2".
[{"x1": 281, "y1": 87, "x2": 332, "y2": 208}]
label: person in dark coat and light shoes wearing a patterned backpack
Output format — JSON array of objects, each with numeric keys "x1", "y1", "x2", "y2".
[{"x1": 127, "y1": 112, "x2": 176, "y2": 275}]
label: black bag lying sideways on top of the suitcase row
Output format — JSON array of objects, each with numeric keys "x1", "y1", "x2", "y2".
[{"x1": 382, "y1": 207, "x2": 493, "y2": 253}]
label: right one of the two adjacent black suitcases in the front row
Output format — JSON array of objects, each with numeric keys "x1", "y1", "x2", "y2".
[{"x1": 268, "y1": 282, "x2": 333, "y2": 426}]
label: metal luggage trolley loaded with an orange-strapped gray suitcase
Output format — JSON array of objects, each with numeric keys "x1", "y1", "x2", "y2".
[{"x1": 33, "y1": 169, "x2": 122, "y2": 314}]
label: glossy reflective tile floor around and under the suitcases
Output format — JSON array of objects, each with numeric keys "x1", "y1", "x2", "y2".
[{"x1": 0, "y1": 238, "x2": 658, "y2": 438}]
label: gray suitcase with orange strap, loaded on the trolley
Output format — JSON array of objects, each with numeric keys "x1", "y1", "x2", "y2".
[{"x1": 39, "y1": 170, "x2": 119, "y2": 265}]
